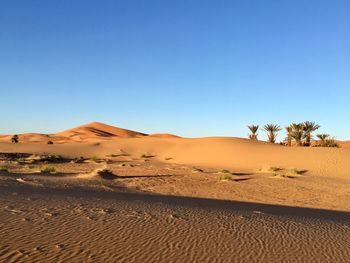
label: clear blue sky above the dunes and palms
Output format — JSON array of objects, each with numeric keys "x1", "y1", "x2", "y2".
[{"x1": 0, "y1": 0, "x2": 350, "y2": 139}]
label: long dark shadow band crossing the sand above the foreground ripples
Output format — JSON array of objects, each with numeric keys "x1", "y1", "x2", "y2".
[{"x1": 0, "y1": 184, "x2": 350, "y2": 222}]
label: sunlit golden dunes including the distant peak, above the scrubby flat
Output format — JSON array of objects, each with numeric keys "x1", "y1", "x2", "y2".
[{"x1": 0, "y1": 122, "x2": 350, "y2": 177}]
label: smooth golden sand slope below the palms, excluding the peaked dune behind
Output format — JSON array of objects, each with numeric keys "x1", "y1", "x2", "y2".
[{"x1": 0, "y1": 137, "x2": 350, "y2": 177}]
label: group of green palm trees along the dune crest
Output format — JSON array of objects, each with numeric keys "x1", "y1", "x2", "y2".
[{"x1": 248, "y1": 121, "x2": 338, "y2": 147}]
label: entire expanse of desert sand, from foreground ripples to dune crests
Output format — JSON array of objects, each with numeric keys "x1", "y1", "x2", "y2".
[{"x1": 0, "y1": 122, "x2": 350, "y2": 262}]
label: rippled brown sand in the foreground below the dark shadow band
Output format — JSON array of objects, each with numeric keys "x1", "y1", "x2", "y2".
[{"x1": 0, "y1": 191, "x2": 350, "y2": 262}]
